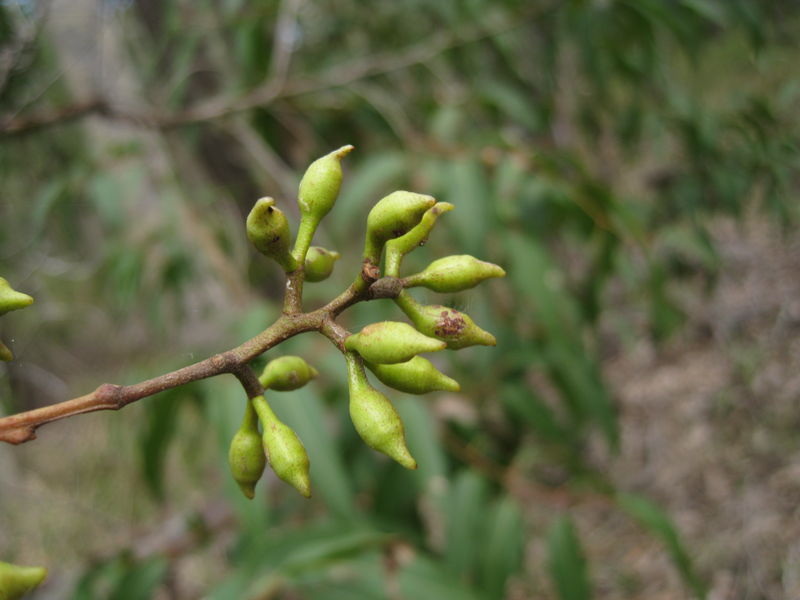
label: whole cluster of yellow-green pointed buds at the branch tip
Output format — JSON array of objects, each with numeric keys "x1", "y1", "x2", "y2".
[{"x1": 229, "y1": 146, "x2": 505, "y2": 498}]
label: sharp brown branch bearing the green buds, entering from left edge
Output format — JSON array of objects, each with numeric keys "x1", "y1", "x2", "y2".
[{"x1": 0, "y1": 268, "x2": 402, "y2": 444}]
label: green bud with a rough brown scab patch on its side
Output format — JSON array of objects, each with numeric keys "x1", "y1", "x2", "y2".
[{"x1": 395, "y1": 290, "x2": 497, "y2": 350}]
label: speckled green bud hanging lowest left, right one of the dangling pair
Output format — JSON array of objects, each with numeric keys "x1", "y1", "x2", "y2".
[{"x1": 253, "y1": 396, "x2": 311, "y2": 498}]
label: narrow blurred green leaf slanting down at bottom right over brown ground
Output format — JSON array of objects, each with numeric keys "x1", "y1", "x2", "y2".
[{"x1": 616, "y1": 494, "x2": 706, "y2": 598}]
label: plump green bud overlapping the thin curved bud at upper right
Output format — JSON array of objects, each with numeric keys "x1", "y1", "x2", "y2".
[{"x1": 364, "y1": 191, "x2": 436, "y2": 263}]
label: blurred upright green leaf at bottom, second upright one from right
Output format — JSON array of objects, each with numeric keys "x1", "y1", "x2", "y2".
[{"x1": 479, "y1": 496, "x2": 525, "y2": 598}]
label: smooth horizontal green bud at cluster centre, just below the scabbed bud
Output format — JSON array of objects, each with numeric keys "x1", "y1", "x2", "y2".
[{"x1": 344, "y1": 321, "x2": 447, "y2": 364}]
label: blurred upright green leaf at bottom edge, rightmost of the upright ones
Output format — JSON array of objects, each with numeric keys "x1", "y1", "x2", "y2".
[{"x1": 547, "y1": 516, "x2": 592, "y2": 600}]
